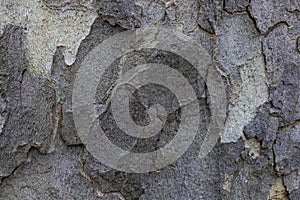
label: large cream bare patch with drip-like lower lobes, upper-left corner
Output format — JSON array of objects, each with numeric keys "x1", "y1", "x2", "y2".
[{"x1": 0, "y1": 0, "x2": 97, "y2": 75}]
